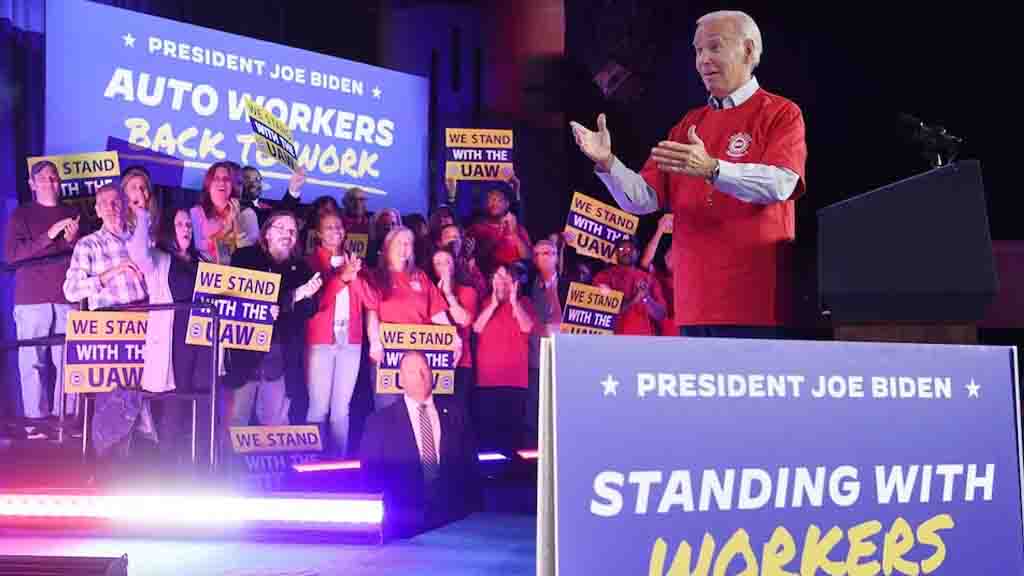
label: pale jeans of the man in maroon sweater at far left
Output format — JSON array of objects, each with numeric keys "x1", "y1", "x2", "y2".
[{"x1": 14, "y1": 303, "x2": 78, "y2": 418}]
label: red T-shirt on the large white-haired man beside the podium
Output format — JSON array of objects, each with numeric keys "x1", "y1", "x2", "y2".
[{"x1": 640, "y1": 89, "x2": 807, "y2": 326}]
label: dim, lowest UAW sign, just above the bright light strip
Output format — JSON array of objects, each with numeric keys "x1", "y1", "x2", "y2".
[{"x1": 229, "y1": 425, "x2": 324, "y2": 490}]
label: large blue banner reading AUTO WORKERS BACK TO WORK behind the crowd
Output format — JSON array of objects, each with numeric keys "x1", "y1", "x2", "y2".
[{"x1": 46, "y1": 0, "x2": 428, "y2": 213}]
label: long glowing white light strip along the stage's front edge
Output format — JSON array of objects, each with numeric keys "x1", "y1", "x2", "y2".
[{"x1": 0, "y1": 494, "x2": 384, "y2": 526}]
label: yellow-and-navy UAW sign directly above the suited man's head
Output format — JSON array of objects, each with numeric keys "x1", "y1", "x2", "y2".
[{"x1": 377, "y1": 324, "x2": 458, "y2": 394}]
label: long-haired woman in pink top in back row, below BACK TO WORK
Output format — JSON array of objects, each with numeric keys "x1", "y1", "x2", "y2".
[{"x1": 188, "y1": 162, "x2": 245, "y2": 265}]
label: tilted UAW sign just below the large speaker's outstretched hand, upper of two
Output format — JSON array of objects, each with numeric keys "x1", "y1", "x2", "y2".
[{"x1": 565, "y1": 192, "x2": 640, "y2": 262}]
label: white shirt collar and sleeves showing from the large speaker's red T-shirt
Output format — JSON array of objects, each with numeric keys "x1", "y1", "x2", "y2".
[{"x1": 595, "y1": 76, "x2": 800, "y2": 210}]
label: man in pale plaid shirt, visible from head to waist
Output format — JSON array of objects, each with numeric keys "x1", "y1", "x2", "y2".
[{"x1": 63, "y1": 184, "x2": 146, "y2": 310}]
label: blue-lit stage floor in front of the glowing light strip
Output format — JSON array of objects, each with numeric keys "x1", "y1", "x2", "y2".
[{"x1": 0, "y1": 513, "x2": 537, "y2": 576}]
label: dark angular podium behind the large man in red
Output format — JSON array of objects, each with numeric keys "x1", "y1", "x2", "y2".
[{"x1": 817, "y1": 160, "x2": 998, "y2": 343}]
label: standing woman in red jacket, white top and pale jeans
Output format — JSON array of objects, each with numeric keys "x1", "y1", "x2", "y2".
[{"x1": 306, "y1": 208, "x2": 370, "y2": 457}]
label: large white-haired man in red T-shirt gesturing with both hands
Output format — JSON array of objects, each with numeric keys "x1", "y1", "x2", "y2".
[{"x1": 571, "y1": 11, "x2": 807, "y2": 337}]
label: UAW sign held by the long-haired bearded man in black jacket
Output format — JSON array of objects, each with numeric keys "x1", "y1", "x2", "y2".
[{"x1": 185, "y1": 262, "x2": 281, "y2": 352}]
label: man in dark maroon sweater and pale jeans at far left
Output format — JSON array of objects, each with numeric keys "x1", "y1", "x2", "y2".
[{"x1": 4, "y1": 160, "x2": 79, "y2": 419}]
